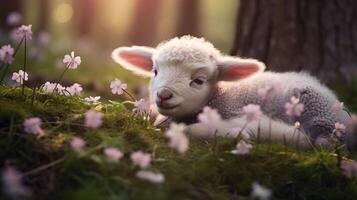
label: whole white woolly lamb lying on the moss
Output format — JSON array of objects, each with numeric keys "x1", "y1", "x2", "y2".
[{"x1": 112, "y1": 36, "x2": 348, "y2": 148}]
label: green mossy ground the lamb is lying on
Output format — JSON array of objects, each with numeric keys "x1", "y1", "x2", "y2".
[{"x1": 0, "y1": 86, "x2": 357, "y2": 200}]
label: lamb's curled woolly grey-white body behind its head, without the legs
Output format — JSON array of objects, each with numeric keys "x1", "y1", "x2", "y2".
[{"x1": 207, "y1": 72, "x2": 348, "y2": 139}]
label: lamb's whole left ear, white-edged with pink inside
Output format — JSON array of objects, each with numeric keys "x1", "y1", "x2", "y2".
[{"x1": 112, "y1": 46, "x2": 155, "y2": 76}]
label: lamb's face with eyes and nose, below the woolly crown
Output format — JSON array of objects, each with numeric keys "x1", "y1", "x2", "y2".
[{"x1": 151, "y1": 61, "x2": 217, "y2": 118}]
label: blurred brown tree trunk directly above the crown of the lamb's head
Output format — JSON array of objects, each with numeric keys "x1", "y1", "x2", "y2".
[{"x1": 177, "y1": 0, "x2": 199, "y2": 36}]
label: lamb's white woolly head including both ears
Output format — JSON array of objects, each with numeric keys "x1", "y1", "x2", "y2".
[{"x1": 112, "y1": 36, "x2": 265, "y2": 119}]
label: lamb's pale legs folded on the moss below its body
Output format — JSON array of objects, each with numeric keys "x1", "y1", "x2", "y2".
[{"x1": 188, "y1": 116, "x2": 311, "y2": 149}]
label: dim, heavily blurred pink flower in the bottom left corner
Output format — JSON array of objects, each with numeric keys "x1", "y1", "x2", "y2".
[{"x1": 2, "y1": 167, "x2": 31, "y2": 197}]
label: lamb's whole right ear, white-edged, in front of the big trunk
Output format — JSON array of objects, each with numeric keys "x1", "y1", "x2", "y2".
[{"x1": 217, "y1": 56, "x2": 265, "y2": 81}]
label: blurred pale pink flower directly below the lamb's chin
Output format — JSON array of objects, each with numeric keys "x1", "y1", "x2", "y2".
[{"x1": 165, "y1": 123, "x2": 189, "y2": 154}]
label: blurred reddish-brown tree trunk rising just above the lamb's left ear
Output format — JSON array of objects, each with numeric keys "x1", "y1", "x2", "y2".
[{"x1": 129, "y1": 0, "x2": 160, "y2": 45}]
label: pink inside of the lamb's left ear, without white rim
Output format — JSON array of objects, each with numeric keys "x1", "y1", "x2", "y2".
[{"x1": 119, "y1": 52, "x2": 153, "y2": 71}]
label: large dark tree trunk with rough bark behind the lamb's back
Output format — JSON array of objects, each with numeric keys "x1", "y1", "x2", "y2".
[{"x1": 231, "y1": 0, "x2": 357, "y2": 81}]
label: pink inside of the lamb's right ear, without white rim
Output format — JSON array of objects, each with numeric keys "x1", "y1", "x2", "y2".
[{"x1": 220, "y1": 65, "x2": 259, "y2": 81}]
